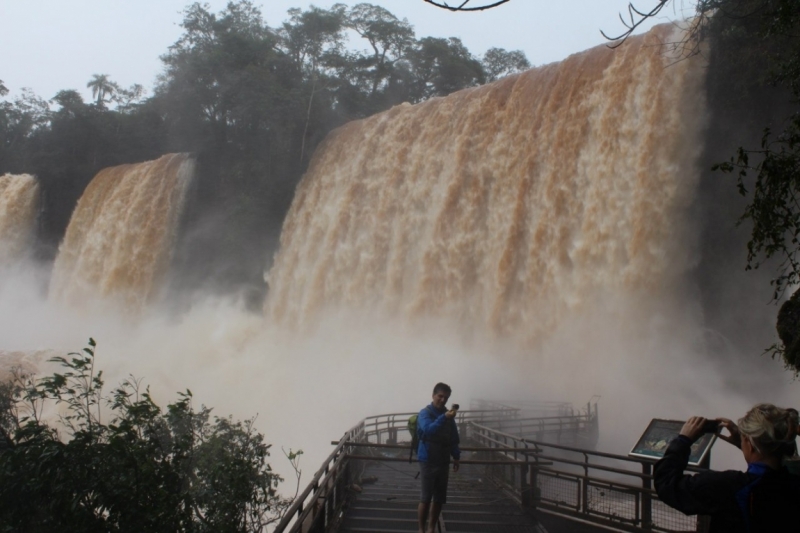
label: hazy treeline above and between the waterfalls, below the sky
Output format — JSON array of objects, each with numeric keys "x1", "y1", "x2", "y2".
[{"x1": 0, "y1": 0, "x2": 530, "y2": 300}]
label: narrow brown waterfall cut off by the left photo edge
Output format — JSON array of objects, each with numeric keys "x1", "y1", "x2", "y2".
[{"x1": 0, "y1": 174, "x2": 39, "y2": 266}]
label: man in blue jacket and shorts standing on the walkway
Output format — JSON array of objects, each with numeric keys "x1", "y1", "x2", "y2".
[{"x1": 417, "y1": 383, "x2": 461, "y2": 533}]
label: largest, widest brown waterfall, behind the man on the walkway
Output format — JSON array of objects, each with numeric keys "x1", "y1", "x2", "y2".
[{"x1": 265, "y1": 25, "x2": 706, "y2": 343}]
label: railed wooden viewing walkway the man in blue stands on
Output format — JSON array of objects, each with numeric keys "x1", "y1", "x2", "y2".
[{"x1": 275, "y1": 401, "x2": 705, "y2": 533}]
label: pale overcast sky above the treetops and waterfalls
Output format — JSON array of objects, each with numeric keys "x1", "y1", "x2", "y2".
[{"x1": 0, "y1": 0, "x2": 690, "y2": 99}]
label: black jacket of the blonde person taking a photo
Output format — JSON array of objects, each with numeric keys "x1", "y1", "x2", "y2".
[{"x1": 654, "y1": 436, "x2": 800, "y2": 533}]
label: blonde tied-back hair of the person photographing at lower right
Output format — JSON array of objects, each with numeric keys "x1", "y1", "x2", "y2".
[{"x1": 737, "y1": 403, "x2": 799, "y2": 457}]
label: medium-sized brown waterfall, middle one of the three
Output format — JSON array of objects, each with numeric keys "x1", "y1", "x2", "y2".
[{"x1": 50, "y1": 154, "x2": 194, "y2": 310}]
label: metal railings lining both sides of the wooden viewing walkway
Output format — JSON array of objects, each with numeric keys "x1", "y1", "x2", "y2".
[{"x1": 275, "y1": 406, "x2": 705, "y2": 533}]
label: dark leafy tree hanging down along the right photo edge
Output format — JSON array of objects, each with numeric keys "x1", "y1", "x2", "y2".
[{"x1": 716, "y1": 0, "x2": 800, "y2": 374}]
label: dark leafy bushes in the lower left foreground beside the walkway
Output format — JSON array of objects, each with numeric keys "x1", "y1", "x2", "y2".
[{"x1": 0, "y1": 339, "x2": 289, "y2": 532}]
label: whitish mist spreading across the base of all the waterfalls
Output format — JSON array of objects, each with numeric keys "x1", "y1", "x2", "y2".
[{"x1": 0, "y1": 268, "x2": 797, "y2": 484}]
